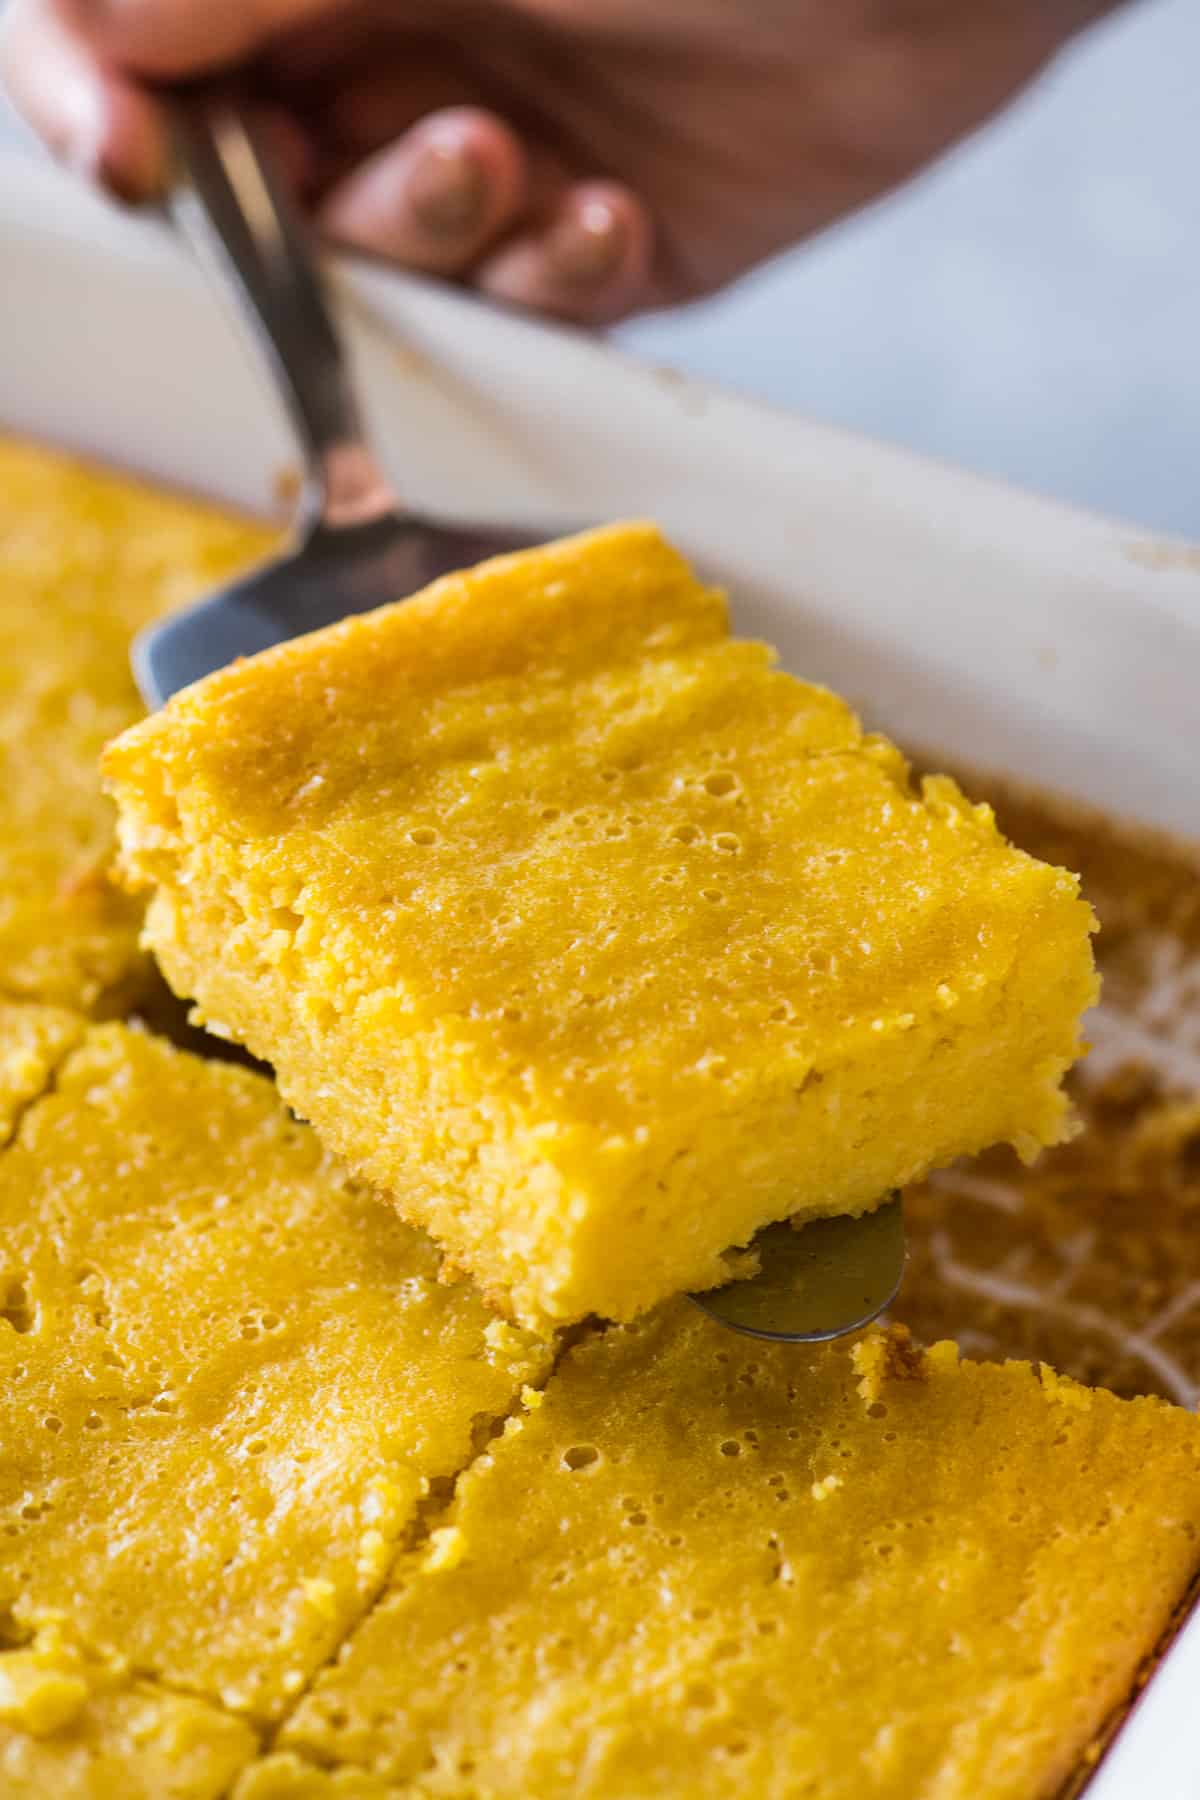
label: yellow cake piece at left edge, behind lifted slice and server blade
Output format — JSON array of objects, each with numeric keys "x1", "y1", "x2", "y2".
[{"x1": 0, "y1": 439, "x2": 272, "y2": 1010}]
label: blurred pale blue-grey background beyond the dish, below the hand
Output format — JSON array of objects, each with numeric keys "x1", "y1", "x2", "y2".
[{"x1": 0, "y1": 0, "x2": 1200, "y2": 538}]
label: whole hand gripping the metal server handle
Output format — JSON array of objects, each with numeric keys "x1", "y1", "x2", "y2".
[{"x1": 0, "y1": 0, "x2": 1112, "y2": 324}]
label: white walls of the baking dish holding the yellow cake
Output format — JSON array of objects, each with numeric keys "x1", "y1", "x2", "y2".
[{"x1": 0, "y1": 151, "x2": 1200, "y2": 1800}]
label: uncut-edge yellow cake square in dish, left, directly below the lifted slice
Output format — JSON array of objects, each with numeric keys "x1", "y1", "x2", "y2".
[{"x1": 0, "y1": 1026, "x2": 545, "y2": 1719}]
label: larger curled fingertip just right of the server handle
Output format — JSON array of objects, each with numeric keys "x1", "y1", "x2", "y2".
[{"x1": 318, "y1": 106, "x2": 527, "y2": 275}]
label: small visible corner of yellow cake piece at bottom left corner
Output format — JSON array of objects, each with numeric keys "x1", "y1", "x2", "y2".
[{"x1": 0, "y1": 1633, "x2": 259, "y2": 1800}]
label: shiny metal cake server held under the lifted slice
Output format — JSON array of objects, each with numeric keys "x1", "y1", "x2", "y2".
[{"x1": 133, "y1": 83, "x2": 905, "y2": 1341}]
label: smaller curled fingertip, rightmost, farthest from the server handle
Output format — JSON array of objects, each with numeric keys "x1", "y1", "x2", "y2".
[{"x1": 473, "y1": 182, "x2": 653, "y2": 326}]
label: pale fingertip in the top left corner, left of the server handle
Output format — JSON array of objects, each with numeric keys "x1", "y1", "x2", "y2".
[{"x1": 0, "y1": 0, "x2": 166, "y2": 200}]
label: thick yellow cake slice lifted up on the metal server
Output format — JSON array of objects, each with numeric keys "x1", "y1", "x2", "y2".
[{"x1": 106, "y1": 526, "x2": 1094, "y2": 1321}]
